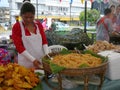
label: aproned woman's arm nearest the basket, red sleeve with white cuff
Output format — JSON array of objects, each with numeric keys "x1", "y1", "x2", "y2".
[{"x1": 37, "y1": 22, "x2": 49, "y2": 54}]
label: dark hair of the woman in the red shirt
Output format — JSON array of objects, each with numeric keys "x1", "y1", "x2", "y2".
[{"x1": 20, "y1": 2, "x2": 35, "y2": 15}]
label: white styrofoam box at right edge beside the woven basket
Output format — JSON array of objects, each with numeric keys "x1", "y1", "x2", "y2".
[{"x1": 98, "y1": 51, "x2": 120, "y2": 80}]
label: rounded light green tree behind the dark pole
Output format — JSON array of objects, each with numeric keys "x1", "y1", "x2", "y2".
[{"x1": 79, "y1": 9, "x2": 100, "y2": 24}]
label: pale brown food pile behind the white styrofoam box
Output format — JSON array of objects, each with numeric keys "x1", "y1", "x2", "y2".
[{"x1": 87, "y1": 41, "x2": 120, "y2": 53}]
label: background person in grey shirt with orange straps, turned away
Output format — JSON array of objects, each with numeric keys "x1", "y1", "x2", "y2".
[{"x1": 96, "y1": 8, "x2": 116, "y2": 42}]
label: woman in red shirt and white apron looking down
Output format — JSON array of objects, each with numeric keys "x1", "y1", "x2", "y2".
[{"x1": 12, "y1": 2, "x2": 48, "y2": 68}]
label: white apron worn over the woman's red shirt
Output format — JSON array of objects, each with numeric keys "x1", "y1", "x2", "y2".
[{"x1": 18, "y1": 22, "x2": 45, "y2": 68}]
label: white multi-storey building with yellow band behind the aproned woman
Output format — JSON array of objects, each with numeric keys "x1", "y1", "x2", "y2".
[{"x1": 8, "y1": 0, "x2": 91, "y2": 24}]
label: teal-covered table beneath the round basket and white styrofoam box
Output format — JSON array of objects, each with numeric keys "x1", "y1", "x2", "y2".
[{"x1": 42, "y1": 77, "x2": 120, "y2": 90}]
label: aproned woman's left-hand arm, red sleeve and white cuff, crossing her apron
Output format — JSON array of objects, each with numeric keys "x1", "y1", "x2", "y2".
[{"x1": 12, "y1": 22, "x2": 35, "y2": 62}]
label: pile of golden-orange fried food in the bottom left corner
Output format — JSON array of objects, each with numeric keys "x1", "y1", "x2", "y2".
[{"x1": 0, "y1": 63, "x2": 40, "y2": 90}]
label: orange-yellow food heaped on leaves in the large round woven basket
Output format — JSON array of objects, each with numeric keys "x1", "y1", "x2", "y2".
[{"x1": 51, "y1": 53, "x2": 102, "y2": 68}]
